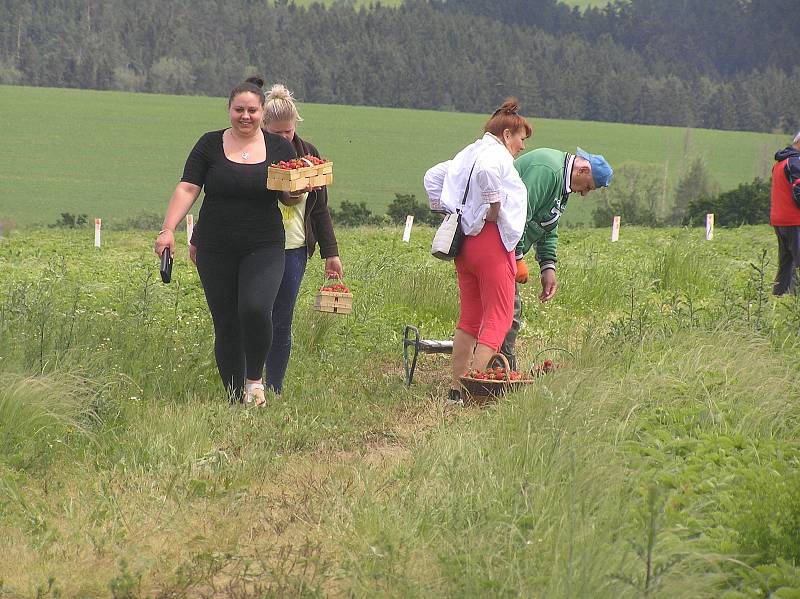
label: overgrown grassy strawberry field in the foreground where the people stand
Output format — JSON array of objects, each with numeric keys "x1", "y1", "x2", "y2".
[{"x1": 0, "y1": 226, "x2": 800, "y2": 599}]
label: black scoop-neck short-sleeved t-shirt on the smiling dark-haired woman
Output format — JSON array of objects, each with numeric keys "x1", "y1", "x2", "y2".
[{"x1": 181, "y1": 129, "x2": 296, "y2": 253}]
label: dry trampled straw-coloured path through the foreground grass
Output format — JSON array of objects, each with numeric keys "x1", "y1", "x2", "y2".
[{"x1": 159, "y1": 398, "x2": 453, "y2": 598}]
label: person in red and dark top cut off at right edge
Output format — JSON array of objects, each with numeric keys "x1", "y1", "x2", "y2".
[{"x1": 769, "y1": 132, "x2": 800, "y2": 295}]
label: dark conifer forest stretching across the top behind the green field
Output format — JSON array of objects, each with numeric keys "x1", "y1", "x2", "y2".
[{"x1": 0, "y1": 0, "x2": 800, "y2": 132}]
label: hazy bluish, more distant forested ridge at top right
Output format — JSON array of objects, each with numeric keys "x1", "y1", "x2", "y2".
[{"x1": 446, "y1": 0, "x2": 800, "y2": 77}]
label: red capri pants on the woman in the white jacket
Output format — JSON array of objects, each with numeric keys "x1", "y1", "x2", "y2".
[{"x1": 455, "y1": 222, "x2": 517, "y2": 351}]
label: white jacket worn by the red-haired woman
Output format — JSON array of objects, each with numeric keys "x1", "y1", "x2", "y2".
[{"x1": 424, "y1": 133, "x2": 528, "y2": 252}]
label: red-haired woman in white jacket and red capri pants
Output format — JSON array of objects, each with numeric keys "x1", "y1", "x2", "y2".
[{"x1": 424, "y1": 98, "x2": 533, "y2": 403}]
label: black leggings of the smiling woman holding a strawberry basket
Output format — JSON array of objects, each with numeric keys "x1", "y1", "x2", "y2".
[{"x1": 197, "y1": 244, "x2": 284, "y2": 399}]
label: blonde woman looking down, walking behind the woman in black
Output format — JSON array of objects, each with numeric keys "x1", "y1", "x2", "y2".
[{"x1": 263, "y1": 84, "x2": 343, "y2": 393}]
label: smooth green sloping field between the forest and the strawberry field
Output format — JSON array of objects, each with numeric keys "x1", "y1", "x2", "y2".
[{"x1": 0, "y1": 86, "x2": 786, "y2": 230}]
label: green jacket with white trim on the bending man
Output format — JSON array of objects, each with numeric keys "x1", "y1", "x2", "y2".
[{"x1": 514, "y1": 148, "x2": 575, "y2": 270}]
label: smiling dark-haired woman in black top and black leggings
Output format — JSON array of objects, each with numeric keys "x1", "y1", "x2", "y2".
[{"x1": 155, "y1": 77, "x2": 300, "y2": 405}]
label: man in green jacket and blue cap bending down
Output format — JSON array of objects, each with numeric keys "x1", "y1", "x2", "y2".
[{"x1": 500, "y1": 148, "x2": 613, "y2": 368}]
